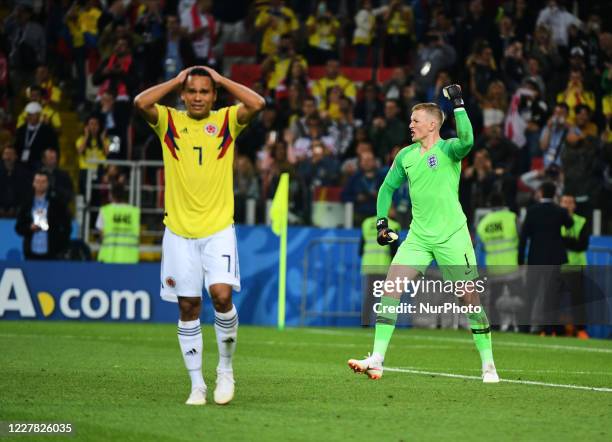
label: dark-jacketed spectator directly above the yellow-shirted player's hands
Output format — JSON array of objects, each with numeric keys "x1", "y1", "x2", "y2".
[{"x1": 162, "y1": 14, "x2": 195, "y2": 81}]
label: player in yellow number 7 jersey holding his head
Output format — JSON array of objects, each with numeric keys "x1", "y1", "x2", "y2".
[{"x1": 134, "y1": 66, "x2": 265, "y2": 405}]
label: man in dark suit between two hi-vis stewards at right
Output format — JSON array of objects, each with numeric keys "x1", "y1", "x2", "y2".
[{"x1": 519, "y1": 182, "x2": 574, "y2": 334}]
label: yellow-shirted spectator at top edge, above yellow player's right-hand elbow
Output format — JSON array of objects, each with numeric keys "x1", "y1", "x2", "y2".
[{"x1": 255, "y1": 0, "x2": 300, "y2": 57}]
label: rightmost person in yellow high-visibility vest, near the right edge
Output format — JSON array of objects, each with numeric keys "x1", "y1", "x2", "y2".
[{"x1": 560, "y1": 194, "x2": 590, "y2": 339}]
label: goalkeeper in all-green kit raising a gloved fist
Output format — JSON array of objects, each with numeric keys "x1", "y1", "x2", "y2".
[{"x1": 348, "y1": 84, "x2": 499, "y2": 383}]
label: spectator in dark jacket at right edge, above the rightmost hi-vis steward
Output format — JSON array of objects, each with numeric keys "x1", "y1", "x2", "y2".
[{"x1": 561, "y1": 106, "x2": 602, "y2": 219}]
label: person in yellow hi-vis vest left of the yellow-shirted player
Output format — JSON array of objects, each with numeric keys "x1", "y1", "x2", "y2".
[{"x1": 96, "y1": 185, "x2": 140, "y2": 264}]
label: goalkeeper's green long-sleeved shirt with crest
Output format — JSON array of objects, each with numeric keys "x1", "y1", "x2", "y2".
[{"x1": 376, "y1": 108, "x2": 474, "y2": 244}]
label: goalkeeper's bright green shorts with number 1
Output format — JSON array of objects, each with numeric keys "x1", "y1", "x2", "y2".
[{"x1": 391, "y1": 225, "x2": 478, "y2": 281}]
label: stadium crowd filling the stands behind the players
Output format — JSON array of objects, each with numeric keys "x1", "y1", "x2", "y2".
[{"x1": 0, "y1": 0, "x2": 612, "y2": 233}]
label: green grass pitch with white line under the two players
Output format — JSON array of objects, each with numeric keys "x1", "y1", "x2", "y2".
[{"x1": 0, "y1": 321, "x2": 612, "y2": 442}]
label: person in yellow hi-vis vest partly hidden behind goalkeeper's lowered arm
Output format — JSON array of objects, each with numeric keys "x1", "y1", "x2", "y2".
[{"x1": 359, "y1": 209, "x2": 401, "y2": 326}]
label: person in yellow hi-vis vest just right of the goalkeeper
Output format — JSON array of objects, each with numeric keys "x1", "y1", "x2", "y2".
[{"x1": 476, "y1": 193, "x2": 523, "y2": 331}]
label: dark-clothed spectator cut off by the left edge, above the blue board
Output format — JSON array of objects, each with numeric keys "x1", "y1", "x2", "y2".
[{"x1": 0, "y1": 144, "x2": 32, "y2": 218}]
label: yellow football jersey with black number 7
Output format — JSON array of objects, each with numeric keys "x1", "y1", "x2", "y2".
[{"x1": 151, "y1": 105, "x2": 245, "y2": 238}]
